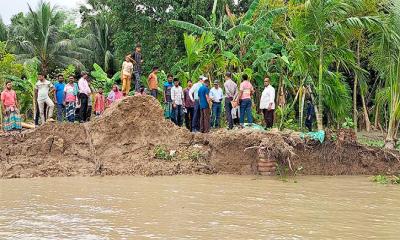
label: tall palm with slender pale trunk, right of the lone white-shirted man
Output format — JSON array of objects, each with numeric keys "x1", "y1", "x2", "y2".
[{"x1": 293, "y1": 0, "x2": 373, "y2": 130}]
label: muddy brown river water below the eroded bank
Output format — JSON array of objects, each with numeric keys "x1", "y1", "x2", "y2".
[{"x1": 0, "y1": 176, "x2": 400, "y2": 239}]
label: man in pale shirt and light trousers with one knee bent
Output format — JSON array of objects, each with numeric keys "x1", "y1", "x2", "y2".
[{"x1": 35, "y1": 74, "x2": 54, "y2": 125}]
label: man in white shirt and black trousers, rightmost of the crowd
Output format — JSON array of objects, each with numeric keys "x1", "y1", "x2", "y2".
[{"x1": 260, "y1": 77, "x2": 275, "y2": 128}]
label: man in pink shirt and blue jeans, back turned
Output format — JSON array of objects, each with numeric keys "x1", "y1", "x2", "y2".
[{"x1": 239, "y1": 74, "x2": 254, "y2": 127}]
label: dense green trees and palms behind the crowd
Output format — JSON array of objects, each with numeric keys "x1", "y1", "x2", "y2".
[{"x1": 0, "y1": 0, "x2": 400, "y2": 147}]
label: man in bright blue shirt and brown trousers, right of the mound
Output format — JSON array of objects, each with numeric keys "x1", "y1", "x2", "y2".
[{"x1": 198, "y1": 80, "x2": 210, "y2": 133}]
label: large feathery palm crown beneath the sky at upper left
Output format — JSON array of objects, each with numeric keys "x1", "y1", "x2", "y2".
[{"x1": 12, "y1": 2, "x2": 84, "y2": 74}]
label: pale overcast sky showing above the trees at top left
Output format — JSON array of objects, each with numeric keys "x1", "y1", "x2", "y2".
[{"x1": 0, "y1": 0, "x2": 85, "y2": 24}]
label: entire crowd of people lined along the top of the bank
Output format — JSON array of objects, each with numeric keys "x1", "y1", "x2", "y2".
[{"x1": 1, "y1": 44, "x2": 318, "y2": 133}]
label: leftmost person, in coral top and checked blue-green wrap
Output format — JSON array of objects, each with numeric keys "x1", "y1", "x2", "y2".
[{"x1": 0, "y1": 81, "x2": 22, "y2": 132}]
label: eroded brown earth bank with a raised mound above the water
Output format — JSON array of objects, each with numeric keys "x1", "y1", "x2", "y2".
[{"x1": 0, "y1": 97, "x2": 400, "y2": 178}]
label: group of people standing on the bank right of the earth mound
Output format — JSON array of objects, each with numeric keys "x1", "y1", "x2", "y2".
[{"x1": 158, "y1": 72, "x2": 275, "y2": 133}]
